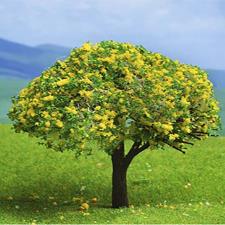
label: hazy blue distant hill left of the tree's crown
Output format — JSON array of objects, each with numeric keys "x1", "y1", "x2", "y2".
[{"x1": 0, "y1": 39, "x2": 70, "y2": 79}]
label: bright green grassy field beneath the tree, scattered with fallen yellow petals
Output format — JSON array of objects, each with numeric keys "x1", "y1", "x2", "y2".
[{"x1": 0, "y1": 125, "x2": 225, "y2": 224}]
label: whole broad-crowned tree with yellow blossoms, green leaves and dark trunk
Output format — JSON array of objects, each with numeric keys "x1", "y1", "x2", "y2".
[{"x1": 9, "y1": 41, "x2": 219, "y2": 208}]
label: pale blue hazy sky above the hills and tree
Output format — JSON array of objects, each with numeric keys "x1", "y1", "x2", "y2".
[{"x1": 0, "y1": 0, "x2": 225, "y2": 69}]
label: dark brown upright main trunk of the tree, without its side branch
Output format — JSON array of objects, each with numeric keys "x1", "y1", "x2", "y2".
[{"x1": 112, "y1": 143, "x2": 129, "y2": 208}]
